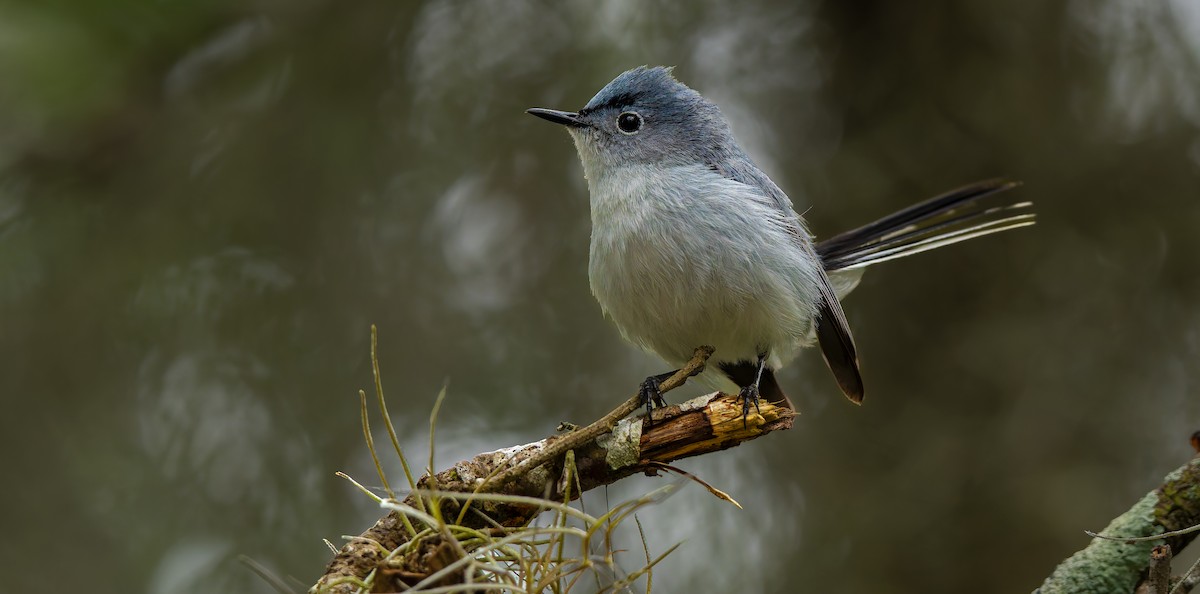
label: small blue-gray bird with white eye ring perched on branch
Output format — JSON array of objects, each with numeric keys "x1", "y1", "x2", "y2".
[{"x1": 528, "y1": 66, "x2": 1033, "y2": 413}]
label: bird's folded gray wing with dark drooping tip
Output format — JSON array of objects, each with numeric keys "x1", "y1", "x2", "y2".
[{"x1": 709, "y1": 156, "x2": 863, "y2": 404}]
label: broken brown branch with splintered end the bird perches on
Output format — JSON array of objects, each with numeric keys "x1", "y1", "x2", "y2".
[{"x1": 313, "y1": 347, "x2": 796, "y2": 594}]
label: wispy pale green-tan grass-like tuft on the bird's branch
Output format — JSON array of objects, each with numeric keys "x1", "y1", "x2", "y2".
[{"x1": 312, "y1": 326, "x2": 679, "y2": 594}]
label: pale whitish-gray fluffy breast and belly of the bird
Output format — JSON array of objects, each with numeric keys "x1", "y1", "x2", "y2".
[{"x1": 580, "y1": 166, "x2": 820, "y2": 376}]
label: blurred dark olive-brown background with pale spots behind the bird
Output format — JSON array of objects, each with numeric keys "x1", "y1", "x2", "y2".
[{"x1": 0, "y1": 0, "x2": 1200, "y2": 593}]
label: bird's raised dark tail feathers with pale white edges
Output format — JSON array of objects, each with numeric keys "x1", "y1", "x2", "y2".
[{"x1": 816, "y1": 179, "x2": 1036, "y2": 271}]
